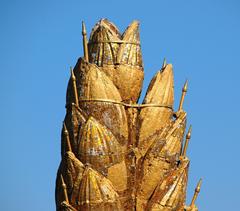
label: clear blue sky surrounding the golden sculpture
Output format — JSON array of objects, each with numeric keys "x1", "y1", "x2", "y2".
[{"x1": 0, "y1": 0, "x2": 240, "y2": 211}]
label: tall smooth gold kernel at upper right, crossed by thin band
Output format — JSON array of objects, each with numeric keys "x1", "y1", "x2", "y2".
[{"x1": 139, "y1": 64, "x2": 174, "y2": 155}]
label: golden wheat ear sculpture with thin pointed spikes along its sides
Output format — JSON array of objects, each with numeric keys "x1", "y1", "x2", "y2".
[{"x1": 55, "y1": 19, "x2": 201, "y2": 211}]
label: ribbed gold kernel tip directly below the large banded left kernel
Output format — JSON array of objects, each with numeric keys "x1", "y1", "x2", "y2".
[{"x1": 78, "y1": 117, "x2": 124, "y2": 173}]
